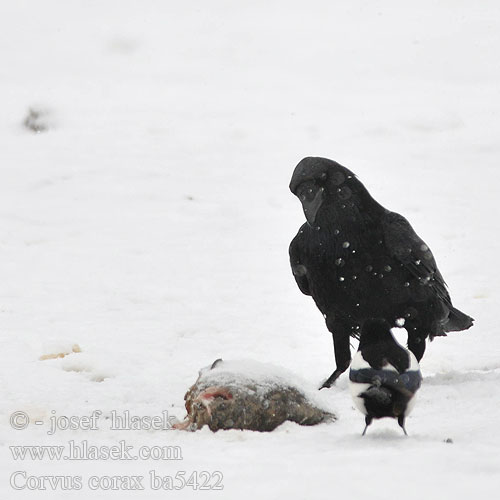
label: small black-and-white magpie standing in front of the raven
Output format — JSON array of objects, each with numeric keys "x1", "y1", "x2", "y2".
[{"x1": 349, "y1": 319, "x2": 422, "y2": 436}]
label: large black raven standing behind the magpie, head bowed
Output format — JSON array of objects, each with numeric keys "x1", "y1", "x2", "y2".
[{"x1": 290, "y1": 157, "x2": 473, "y2": 387}]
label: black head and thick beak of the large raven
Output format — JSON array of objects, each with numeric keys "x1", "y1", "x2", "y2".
[{"x1": 290, "y1": 156, "x2": 368, "y2": 226}]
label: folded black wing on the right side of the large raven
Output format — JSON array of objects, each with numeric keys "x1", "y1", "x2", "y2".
[{"x1": 382, "y1": 212, "x2": 451, "y2": 305}]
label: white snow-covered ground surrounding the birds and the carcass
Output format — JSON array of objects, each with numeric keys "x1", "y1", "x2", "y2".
[{"x1": 0, "y1": 0, "x2": 500, "y2": 500}]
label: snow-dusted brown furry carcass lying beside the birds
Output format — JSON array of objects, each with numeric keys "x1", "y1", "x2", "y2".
[{"x1": 174, "y1": 359, "x2": 336, "y2": 432}]
